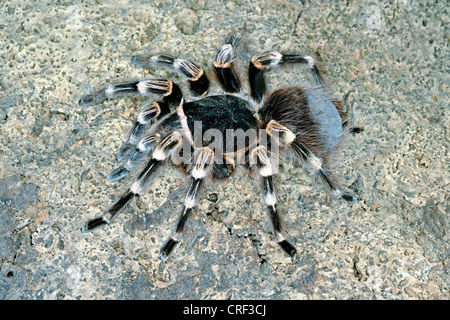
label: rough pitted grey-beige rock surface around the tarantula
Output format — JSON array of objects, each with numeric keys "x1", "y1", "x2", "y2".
[{"x1": 0, "y1": 0, "x2": 450, "y2": 300}]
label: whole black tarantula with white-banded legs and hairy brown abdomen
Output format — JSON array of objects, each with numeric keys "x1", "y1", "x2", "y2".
[{"x1": 80, "y1": 35, "x2": 357, "y2": 260}]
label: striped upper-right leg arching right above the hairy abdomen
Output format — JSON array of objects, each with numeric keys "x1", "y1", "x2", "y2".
[{"x1": 248, "y1": 51, "x2": 325, "y2": 102}]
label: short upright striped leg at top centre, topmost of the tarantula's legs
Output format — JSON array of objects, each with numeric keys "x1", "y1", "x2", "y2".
[{"x1": 214, "y1": 35, "x2": 242, "y2": 93}]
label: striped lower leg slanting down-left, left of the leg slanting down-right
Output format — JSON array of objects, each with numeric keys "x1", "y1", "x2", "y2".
[{"x1": 159, "y1": 147, "x2": 214, "y2": 259}]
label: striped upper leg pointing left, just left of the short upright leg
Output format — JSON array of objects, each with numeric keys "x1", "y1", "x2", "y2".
[{"x1": 132, "y1": 55, "x2": 209, "y2": 96}]
